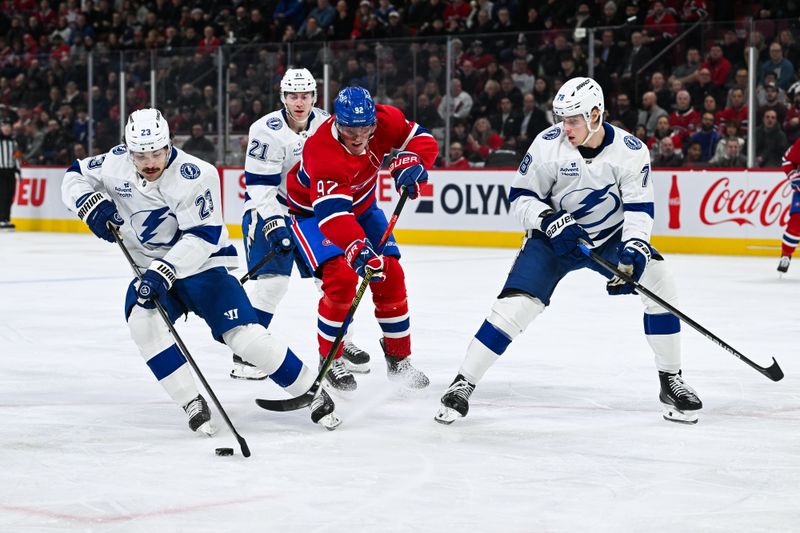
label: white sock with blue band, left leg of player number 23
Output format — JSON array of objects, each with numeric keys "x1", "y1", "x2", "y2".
[{"x1": 128, "y1": 305, "x2": 198, "y2": 407}]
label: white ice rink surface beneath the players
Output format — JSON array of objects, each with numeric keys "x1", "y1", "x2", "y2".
[{"x1": 0, "y1": 233, "x2": 800, "y2": 532}]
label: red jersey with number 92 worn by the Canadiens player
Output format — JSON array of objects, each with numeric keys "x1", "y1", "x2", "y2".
[{"x1": 286, "y1": 104, "x2": 439, "y2": 250}]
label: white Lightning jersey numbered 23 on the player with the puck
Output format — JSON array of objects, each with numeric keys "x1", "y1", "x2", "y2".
[{"x1": 61, "y1": 145, "x2": 238, "y2": 278}]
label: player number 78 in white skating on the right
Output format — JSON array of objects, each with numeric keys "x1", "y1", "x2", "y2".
[{"x1": 435, "y1": 78, "x2": 702, "y2": 424}]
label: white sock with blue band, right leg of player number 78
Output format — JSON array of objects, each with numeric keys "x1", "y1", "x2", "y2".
[{"x1": 641, "y1": 261, "x2": 681, "y2": 373}]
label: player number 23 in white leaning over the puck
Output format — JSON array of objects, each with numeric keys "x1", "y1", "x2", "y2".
[{"x1": 62, "y1": 109, "x2": 339, "y2": 436}]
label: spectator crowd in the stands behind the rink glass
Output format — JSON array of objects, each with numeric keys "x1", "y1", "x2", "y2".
[{"x1": 0, "y1": 0, "x2": 800, "y2": 168}]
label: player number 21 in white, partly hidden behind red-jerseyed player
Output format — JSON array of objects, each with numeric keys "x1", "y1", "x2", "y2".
[{"x1": 231, "y1": 68, "x2": 369, "y2": 390}]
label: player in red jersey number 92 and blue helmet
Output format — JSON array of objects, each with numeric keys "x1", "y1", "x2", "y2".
[{"x1": 287, "y1": 87, "x2": 439, "y2": 391}]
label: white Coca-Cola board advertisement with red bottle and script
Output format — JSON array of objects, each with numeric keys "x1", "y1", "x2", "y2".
[{"x1": 653, "y1": 170, "x2": 792, "y2": 241}]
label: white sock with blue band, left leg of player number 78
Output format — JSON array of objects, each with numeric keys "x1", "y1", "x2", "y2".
[{"x1": 459, "y1": 294, "x2": 544, "y2": 384}]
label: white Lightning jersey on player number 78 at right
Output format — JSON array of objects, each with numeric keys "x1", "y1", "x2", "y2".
[{"x1": 509, "y1": 123, "x2": 654, "y2": 246}]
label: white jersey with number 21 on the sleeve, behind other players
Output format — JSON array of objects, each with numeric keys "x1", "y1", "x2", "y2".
[{"x1": 244, "y1": 107, "x2": 330, "y2": 219}]
